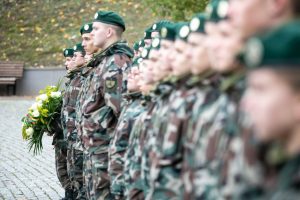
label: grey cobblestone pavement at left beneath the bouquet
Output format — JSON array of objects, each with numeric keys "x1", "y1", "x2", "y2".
[{"x1": 0, "y1": 99, "x2": 64, "y2": 200}]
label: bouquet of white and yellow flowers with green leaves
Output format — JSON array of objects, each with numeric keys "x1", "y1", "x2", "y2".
[{"x1": 22, "y1": 85, "x2": 62, "y2": 155}]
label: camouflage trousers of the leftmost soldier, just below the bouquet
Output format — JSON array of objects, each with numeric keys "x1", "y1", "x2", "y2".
[{"x1": 54, "y1": 140, "x2": 71, "y2": 190}]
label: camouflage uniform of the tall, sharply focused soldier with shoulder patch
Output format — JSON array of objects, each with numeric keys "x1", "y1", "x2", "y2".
[{"x1": 79, "y1": 42, "x2": 132, "y2": 199}]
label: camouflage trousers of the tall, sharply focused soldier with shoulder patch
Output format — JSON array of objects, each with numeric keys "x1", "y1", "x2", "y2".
[{"x1": 83, "y1": 151, "x2": 114, "y2": 200}]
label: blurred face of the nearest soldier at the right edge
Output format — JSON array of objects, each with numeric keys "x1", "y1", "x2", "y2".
[{"x1": 242, "y1": 69, "x2": 300, "y2": 142}]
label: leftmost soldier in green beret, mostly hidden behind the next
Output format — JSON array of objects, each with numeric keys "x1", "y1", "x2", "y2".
[{"x1": 53, "y1": 49, "x2": 74, "y2": 199}]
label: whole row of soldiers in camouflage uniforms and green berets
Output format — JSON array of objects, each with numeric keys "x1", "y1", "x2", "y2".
[{"x1": 55, "y1": 0, "x2": 300, "y2": 200}]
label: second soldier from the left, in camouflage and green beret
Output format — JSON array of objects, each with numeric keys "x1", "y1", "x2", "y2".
[{"x1": 61, "y1": 43, "x2": 86, "y2": 199}]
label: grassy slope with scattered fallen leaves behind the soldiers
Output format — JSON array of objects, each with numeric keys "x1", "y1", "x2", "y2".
[{"x1": 0, "y1": 0, "x2": 207, "y2": 67}]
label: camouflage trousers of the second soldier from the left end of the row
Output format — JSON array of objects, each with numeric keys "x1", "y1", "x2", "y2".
[{"x1": 67, "y1": 142, "x2": 87, "y2": 200}]
